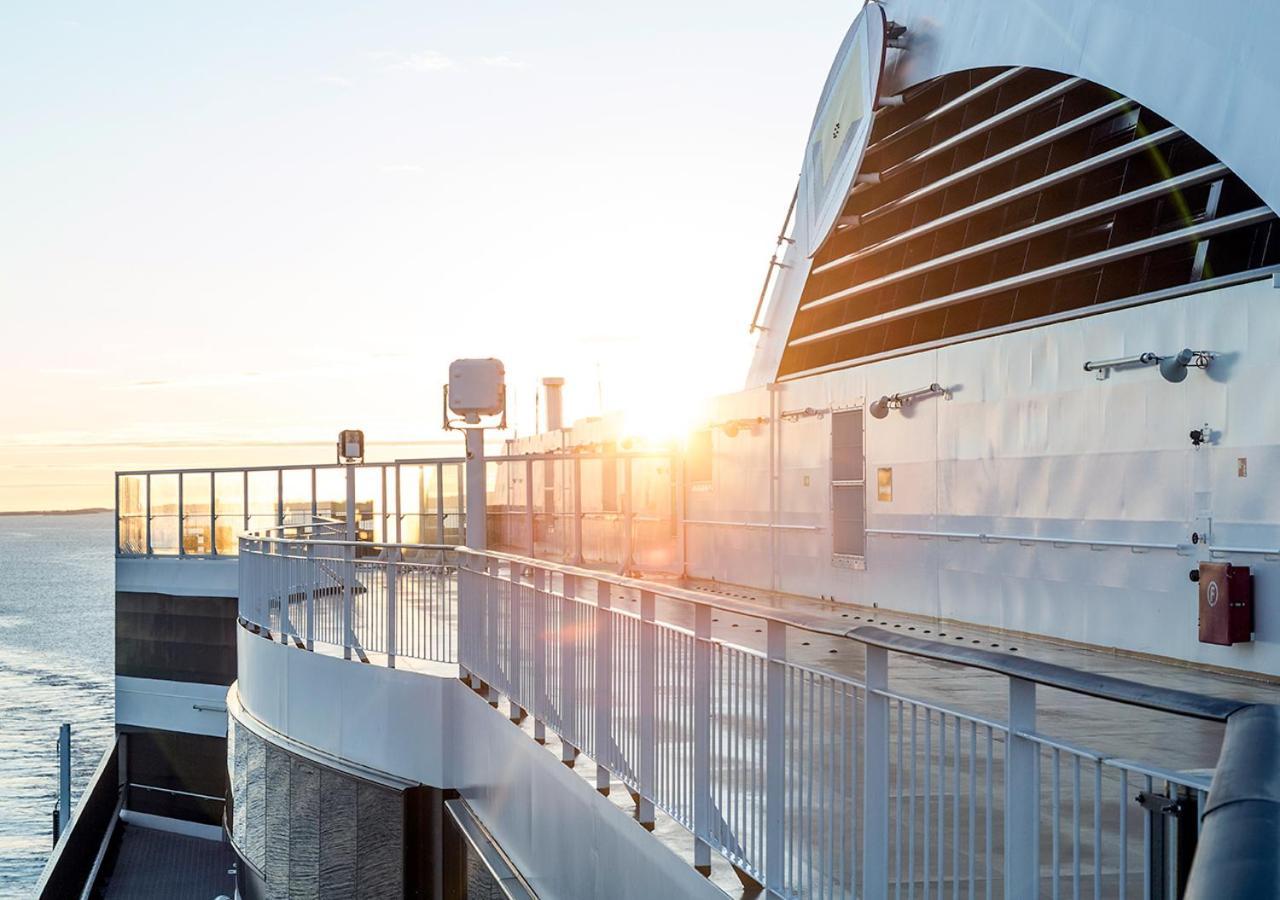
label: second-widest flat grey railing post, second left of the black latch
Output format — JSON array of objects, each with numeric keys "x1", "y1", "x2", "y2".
[{"x1": 854, "y1": 645, "x2": 890, "y2": 900}]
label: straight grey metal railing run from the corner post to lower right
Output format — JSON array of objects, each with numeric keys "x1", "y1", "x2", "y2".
[{"x1": 458, "y1": 550, "x2": 1264, "y2": 900}]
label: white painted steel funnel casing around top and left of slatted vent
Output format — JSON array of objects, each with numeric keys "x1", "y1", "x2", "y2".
[{"x1": 748, "y1": 0, "x2": 1280, "y2": 387}]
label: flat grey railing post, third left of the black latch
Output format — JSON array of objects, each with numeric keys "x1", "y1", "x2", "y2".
[{"x1": 764, "y1": 620, "x2": 787, "y2": 895}]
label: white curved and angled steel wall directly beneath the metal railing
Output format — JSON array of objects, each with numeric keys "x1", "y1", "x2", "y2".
[{"x1": 233, "y1": 629, "x2": 724, "y2": 900}]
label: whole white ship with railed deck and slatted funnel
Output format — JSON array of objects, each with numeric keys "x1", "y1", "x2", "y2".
[{"x1": 38, "y1": 0, "x2": 1280, "y2": 900}]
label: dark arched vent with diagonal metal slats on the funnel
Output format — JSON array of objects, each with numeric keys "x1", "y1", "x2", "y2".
[{"x1": 778, "y1": 69, "x2": 1280, "y2": 378}]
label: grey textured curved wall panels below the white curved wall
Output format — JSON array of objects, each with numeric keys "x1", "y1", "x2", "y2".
[{"x1": 228, "y1": 718, "x2": 404, "y2": 899}]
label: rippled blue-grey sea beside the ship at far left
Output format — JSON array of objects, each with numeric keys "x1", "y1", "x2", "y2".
[{"x1": 0, "y1": 513, "x2": 115, "y2": 897}]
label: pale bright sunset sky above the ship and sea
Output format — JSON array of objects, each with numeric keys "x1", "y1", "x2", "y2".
[{"x1": 0, "y1": 0, "x2": 860, "y2": 511}]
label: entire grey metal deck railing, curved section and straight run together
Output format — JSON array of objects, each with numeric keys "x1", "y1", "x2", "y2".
[{"x1": 239, "y1": 532, "x2": 1280, "y2": 900}]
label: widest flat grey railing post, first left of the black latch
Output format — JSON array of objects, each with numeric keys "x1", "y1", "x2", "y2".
[{"x1": 1005, "y1": 677, "x2": 1034, "y2": 900}]
